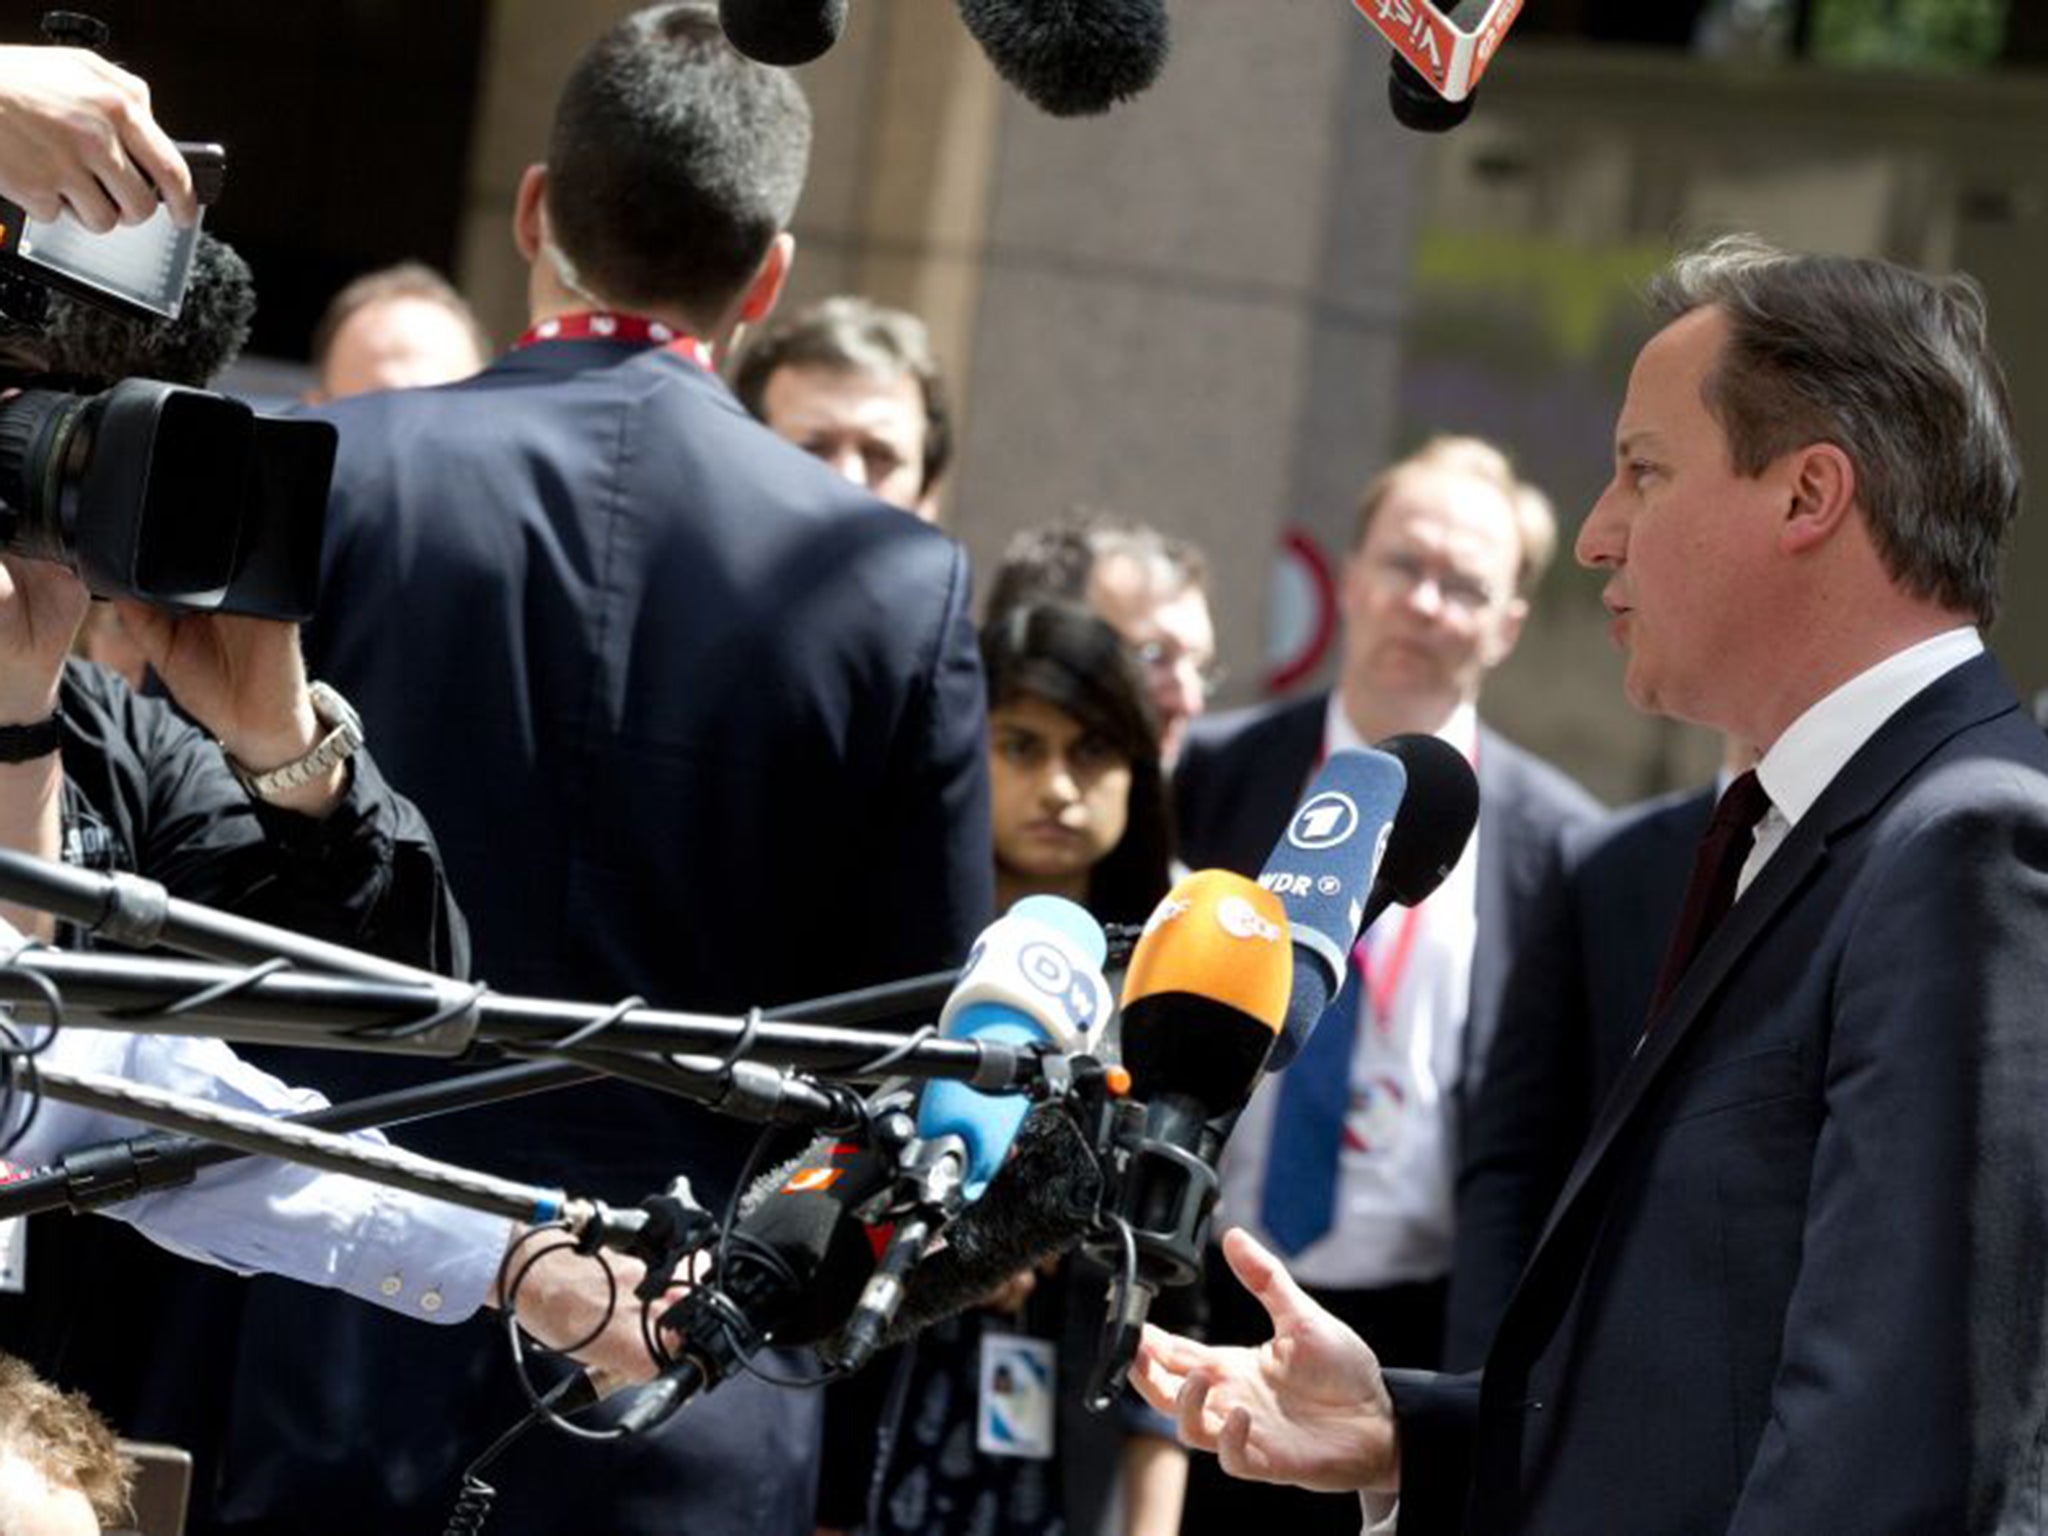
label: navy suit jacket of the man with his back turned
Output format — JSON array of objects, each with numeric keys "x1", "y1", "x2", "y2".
[{"x1": 211, "y1": 340, "x2": 991, "y2": 1536}]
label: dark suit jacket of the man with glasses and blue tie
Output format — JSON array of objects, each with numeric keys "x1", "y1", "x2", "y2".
[{"x1": 1174, "y1": 694, "x2": 1599, "y2": 1104}]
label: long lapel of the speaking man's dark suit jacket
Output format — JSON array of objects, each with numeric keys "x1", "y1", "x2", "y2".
[{"x1": 1501, "y1": 655, "x2": 2015, "y2": 1335}]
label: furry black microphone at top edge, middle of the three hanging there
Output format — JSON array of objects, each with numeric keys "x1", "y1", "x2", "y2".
[{"x1": 961, "y1": 0, "x2": 1167, "y2": 117}]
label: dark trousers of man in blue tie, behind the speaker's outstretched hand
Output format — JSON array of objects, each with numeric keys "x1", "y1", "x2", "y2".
[{"x1": 1180, "y1": 1247, "x2": 1448, "y2": 1536}]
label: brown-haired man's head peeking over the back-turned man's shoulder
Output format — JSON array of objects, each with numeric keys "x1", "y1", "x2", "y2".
[{"x1": 733, "y1": 295, "x2": 952, "y2": 522}]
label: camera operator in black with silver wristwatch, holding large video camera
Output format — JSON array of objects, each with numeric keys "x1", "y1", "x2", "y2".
[{"x1": 0, "y1": 236, "x2": 469, "y2": 975}]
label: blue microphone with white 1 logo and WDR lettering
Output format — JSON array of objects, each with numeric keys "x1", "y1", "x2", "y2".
[{"x1": 1260, "y1": 750, "x2": 1407, "y2": 1071}]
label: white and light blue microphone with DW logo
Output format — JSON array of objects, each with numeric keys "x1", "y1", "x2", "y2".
[{"x1": 918, "y1": 895, "x2": 1112, "y2": 1200}]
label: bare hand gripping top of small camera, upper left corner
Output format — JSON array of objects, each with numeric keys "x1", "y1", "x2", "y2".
[{"x1": 0, "y1": 45, "x2": 199, "y2": 233}]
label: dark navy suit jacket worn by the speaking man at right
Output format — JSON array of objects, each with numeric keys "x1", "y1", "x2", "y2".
[{"x1": 1391, "y1": 657, "x2": 2048, "y2": 1536}]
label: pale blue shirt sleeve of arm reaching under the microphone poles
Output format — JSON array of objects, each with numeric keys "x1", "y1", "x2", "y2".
[{"x1": 0, "y1": 1026, "x2": 512, "y2": 1323}]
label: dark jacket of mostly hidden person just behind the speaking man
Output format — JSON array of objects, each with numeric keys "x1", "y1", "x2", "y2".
[{"x1": 1444, "y1": 788, "x2": 1714, "y2": 1370}]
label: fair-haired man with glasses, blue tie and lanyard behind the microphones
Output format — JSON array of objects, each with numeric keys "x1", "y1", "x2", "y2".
[{"x1": 1174, "y1": 436, "x2": 1597, "y2": 1536}]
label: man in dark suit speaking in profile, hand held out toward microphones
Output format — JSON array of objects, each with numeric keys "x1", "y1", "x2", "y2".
[{"x1": 1139, "y1": 240, "x2": 2048, "y2": 1536}]
